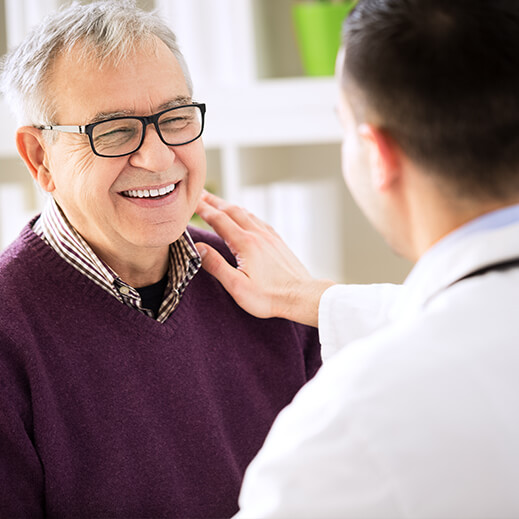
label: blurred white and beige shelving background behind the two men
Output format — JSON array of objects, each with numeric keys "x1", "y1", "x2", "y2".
[{"x1": 0, "y1": 0, "x2": 410, "y2": 283}]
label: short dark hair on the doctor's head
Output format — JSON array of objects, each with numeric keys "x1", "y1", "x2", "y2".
[{"x1": 342, "y1": 0, "x2": 519, "y2": 199}]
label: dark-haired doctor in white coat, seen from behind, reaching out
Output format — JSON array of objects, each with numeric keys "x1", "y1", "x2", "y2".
[{"x1": 195, "y1": 0, "x2": 519, "y2": 519}]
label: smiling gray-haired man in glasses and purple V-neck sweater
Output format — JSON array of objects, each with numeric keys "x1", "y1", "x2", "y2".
[{"x1": 0, "y1": 1, "x2": 320, "y2": 518}]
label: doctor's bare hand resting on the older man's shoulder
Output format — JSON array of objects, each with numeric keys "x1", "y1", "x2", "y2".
[{"x1": 195, "y1": 192, "x2": 334, "y2": 326}]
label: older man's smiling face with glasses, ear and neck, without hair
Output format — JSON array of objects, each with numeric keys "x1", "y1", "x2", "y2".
[{"x1": 26, "y1": 36, "x2": 206, "y2": 296}]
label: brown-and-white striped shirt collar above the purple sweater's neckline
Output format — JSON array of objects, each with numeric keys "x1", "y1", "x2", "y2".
[{"x1": 33, "y1": 198, "x2": 201, "y2": 323}]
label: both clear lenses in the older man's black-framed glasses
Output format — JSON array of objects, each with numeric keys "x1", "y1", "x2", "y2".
[{"x1": 92, "y1": 106, "x2": 202, "y2": 156}]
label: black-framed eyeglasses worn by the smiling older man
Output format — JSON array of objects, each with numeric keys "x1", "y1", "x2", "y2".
[{"x1": 38, "y1": 103, "x2": 205, "y2": 157}]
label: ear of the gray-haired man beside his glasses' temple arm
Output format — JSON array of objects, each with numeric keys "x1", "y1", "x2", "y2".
[{"x1": 16, "y1": 126, "x2": 55, "y2": 193}]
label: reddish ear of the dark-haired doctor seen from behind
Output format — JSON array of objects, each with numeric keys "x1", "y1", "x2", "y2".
[{"x1": 358, "y1": 124, "x2": 401, "y2": 190}]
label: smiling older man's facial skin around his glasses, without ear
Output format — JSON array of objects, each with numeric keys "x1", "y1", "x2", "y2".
[{"x1": 44, "y1": 37, "x2": 206, "y2": 260}]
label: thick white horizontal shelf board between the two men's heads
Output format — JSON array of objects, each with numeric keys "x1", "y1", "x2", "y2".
[{"x1": 199, "y1": 78, "x2": 341, "y2": 147}]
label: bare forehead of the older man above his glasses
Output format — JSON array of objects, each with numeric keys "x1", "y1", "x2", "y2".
[{"x1": 47, "y1": 36, "x2": 190, "y2": 124}]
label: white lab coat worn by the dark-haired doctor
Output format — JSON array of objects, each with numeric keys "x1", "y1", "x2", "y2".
[{"x1": 238, "y1": 218, "x2": 519, "y2": 519}]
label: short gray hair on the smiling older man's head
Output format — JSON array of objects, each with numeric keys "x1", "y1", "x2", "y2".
[{"x1": 0, "y1": 0, "x2": 193, "y2": 125}]
